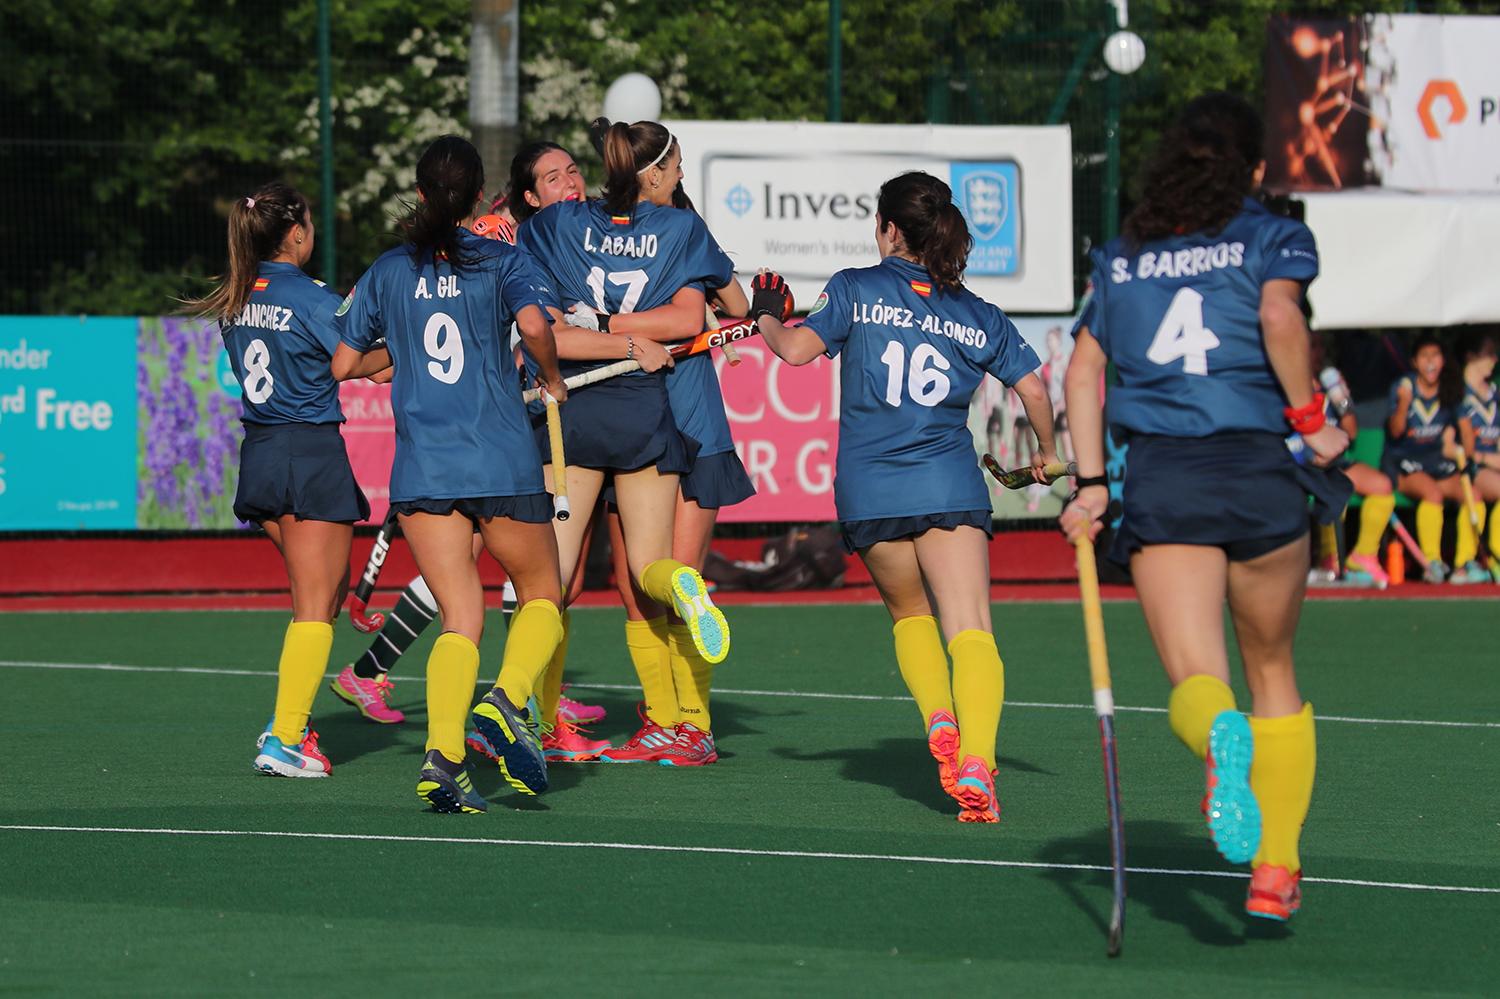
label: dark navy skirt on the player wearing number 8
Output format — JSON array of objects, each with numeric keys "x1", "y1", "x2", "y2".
[{"x1": 234, "y1": 423, "x2": 371, "y2": 524}]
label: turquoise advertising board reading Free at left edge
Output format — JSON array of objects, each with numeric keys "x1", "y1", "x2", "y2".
[{"x1": 0, "y1": 317, "x2": 137, "y2": 531}]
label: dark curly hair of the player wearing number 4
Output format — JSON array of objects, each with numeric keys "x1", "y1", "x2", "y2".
[{"x1": 1124, "y1": 93, "x2": 1265, "y2": 246}]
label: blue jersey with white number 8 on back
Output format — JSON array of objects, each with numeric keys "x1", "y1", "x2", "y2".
[{"x1": 219, "y1": 263, "x2": 344, "y2": 423}]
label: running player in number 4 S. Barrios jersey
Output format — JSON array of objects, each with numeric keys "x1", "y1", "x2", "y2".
[{"x1": 1061, "y1": 93, "x2": 1350, "y2": 920}]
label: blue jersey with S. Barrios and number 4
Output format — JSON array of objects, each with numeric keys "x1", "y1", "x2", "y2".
[{"x1": 1074, "y1": 198, "x2": 1317, "y2": 437}]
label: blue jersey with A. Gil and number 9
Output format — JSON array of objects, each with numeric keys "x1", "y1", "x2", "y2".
[{"x1": 339, "y1": 231, "x2": 554, "y2": 503}]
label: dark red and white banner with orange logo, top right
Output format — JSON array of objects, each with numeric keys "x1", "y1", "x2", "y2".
[{"x1": 1266, "y1": 14, "x2": 1500, "y2": 192}]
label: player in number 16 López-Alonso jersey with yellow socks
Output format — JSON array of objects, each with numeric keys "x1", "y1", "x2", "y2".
[{"x1": 752, "y1": 173, "x2": 1058, "y2": 822}]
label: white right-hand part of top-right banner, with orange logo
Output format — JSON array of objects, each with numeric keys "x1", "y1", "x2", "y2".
[{"x1": 1365, "y1": 15, "x2": 1500, "y2": 192}]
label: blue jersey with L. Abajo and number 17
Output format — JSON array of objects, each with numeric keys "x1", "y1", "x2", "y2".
[{"x1": 516, "y1": 201, "x2": 735, "y2": 375}]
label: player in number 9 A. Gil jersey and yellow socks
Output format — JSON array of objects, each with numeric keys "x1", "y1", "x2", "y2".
[{"x1": 333, "y1": 135, "x2": 567, "y2": 812}]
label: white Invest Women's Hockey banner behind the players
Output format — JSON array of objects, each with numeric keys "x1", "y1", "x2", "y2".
[{"x1": 666, "y1": 122, "x2": 1073, "y2": 312}]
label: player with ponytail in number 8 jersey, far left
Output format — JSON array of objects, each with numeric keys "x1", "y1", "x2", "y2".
[{"x1": 191, "y1": 185, "x2": 378, "y2": 777}]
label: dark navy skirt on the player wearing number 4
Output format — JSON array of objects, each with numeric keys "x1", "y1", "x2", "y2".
[{"x1": 1110, "y1": 432, "x2": 1353, "y2": 564}]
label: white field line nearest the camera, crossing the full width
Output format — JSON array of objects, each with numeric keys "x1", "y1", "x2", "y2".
[{"x1": 0, "y1": 825, "x2": 1500, "y2": 896}]
